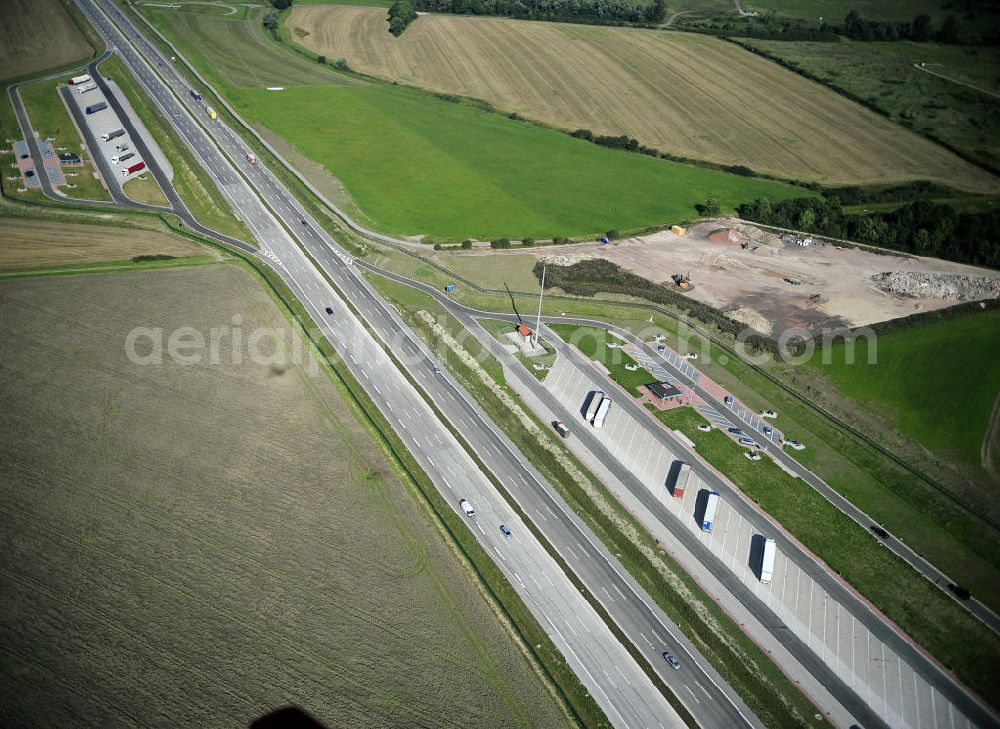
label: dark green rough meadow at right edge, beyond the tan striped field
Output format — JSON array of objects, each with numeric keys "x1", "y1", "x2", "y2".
[{"x1": 742, "y1": 39, "x2": 1000, "y2": 175}]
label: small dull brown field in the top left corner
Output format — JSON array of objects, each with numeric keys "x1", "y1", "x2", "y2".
[{"x1": 0, "y1": 0, "x2": 93, "y2": 80}]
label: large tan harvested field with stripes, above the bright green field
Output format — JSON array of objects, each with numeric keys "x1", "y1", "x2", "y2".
[{"x1": 286, "y1": 6, "x2": 1000, "y2": 192}]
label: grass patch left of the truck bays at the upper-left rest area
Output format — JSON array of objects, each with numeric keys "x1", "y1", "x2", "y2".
[{"x1": 20, "y1": 79, "x2": 111, "y2": 200}]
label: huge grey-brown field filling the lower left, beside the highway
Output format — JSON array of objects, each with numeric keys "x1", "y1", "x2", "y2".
[{"x1": 0, "y1": 264, "x2": 566, "y2": 727}]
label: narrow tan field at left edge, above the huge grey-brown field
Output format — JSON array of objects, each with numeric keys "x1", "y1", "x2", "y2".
[{"x1": 0, "y1": 217, "x2": 212, "y2": 268}]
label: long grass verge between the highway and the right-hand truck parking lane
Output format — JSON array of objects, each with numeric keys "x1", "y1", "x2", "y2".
[{"x1": 371, "y1": 276, "x2": 821, "y2": 727}]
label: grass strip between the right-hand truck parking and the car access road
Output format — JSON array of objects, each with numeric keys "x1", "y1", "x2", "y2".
[{"x1": 654, "y1": 408, "x2": 1000, "y2": 696}]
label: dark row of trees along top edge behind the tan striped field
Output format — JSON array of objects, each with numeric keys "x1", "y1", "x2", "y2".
[{"x1": 414, "y1": 0, "x2": 666, "y2": 25}]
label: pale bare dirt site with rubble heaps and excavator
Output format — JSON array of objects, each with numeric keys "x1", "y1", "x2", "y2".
[{"x1": 535, "y1": 220, "x2": 1000, "y2": 335}]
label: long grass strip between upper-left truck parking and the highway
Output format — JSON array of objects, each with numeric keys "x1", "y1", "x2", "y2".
[{"x1": 100, "y1": 57, "x2": 256, "y2": 245}]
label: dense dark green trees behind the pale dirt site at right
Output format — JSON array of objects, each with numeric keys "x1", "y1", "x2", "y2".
[{"x1": 737, "y1": 196, "x2": 1000, "y2": 268}]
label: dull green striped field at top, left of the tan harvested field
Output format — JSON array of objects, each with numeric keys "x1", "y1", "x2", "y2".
[{"x1": 139, "y1": 5, "x2": 357, "y2": 88}]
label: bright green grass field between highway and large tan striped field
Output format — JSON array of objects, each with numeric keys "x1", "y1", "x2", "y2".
[{"x1": 144, "y1": 5, "x2": 803, "y2": 240}]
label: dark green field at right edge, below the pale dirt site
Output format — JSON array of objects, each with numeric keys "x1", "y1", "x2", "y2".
[{"x1": 809, "y1": 310, "x2": 1000, "y2": 468}]
